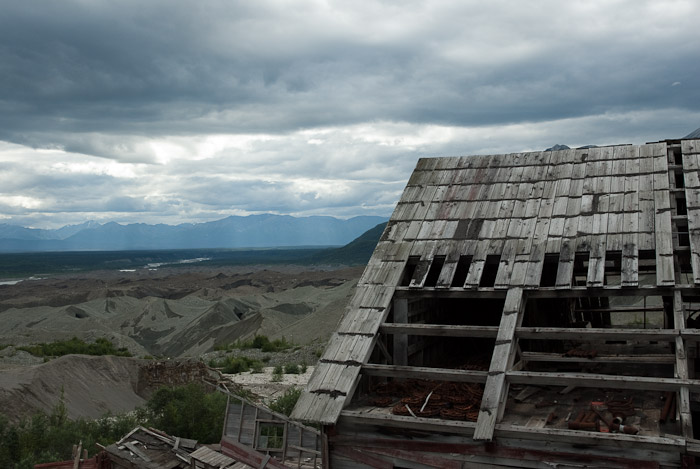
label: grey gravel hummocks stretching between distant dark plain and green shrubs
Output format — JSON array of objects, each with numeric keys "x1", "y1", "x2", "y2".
[{"x1": 0, "y1": 266, "x2": 362, "y2": 357}]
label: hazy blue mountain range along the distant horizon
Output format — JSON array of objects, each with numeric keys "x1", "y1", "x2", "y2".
[{"x1": 0, "y1": 214, "x2": 387, "y2": 252}]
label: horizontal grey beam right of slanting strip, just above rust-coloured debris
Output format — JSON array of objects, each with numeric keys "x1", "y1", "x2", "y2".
[{"x1": 506, "y1": 371, "x2": 700, "y2": 392}]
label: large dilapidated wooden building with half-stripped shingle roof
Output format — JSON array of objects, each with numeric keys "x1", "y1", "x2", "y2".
[{"x1": 292, "y1": 139, "x2": 700, "y2": 468}]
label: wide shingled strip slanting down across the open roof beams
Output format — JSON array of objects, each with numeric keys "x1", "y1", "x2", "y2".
[{"x1": 474, "y1": 287, "x2": 525, "y2": 441}]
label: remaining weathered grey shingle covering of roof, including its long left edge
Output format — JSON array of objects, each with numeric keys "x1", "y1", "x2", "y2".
[{"x1": 292, "y1": 140, "x2": 700, "y2": 424}]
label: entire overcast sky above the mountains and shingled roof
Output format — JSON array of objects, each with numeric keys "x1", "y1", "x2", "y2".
[{"x1": 0, "y1": 0, "x2": 700, "y2": 228}]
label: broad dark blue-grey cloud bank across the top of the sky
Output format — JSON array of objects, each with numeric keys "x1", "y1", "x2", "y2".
[{"x1": 0, "y1": 1, "x2": 700, "y2": 151}]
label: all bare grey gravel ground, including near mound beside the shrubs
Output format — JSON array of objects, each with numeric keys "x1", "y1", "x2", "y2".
[{"x1": 0, "y1": 266, "x2": 362, "y2": 419}]
